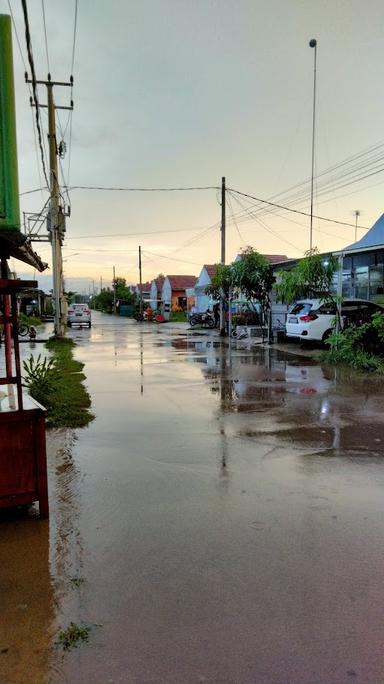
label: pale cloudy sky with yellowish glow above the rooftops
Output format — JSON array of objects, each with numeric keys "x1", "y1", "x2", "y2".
[{"x1": 0, "y1": 0, "x2": 384, "y2": 293}]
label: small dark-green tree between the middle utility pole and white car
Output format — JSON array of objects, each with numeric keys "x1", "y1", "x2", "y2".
[{"x1": 231, "y1": 247, "x2": 274, "y2": 320}]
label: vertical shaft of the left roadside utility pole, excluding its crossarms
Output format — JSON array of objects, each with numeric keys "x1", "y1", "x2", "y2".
[{"x1": 46, "y1": 81, "x2": 64, "y2": 337}]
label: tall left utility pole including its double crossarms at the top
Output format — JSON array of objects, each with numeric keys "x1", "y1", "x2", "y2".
[{"x1": 25, "y1": 73, "x2": 73, "y2": 337}]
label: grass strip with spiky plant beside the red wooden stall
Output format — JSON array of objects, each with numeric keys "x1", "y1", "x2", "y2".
[{"x1": 24, "y1": 339, "x2": 94, "y2": 428}]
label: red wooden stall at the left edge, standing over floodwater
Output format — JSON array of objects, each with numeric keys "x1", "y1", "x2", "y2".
[{"x1": 0, "y1": 278, "x2": 49, "y2": 518}]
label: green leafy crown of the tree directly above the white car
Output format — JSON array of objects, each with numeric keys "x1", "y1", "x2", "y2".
[{"x1": 276, "y1": 249, "x2": 338, "y2": 304}]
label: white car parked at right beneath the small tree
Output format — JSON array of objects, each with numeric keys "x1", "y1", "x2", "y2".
[{"x1": 285, "y1": 299, "x2": 384, "y2": 342}]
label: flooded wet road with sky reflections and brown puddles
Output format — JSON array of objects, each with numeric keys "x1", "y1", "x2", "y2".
[{"x1": 0, "y1": 314, "x2": 384, "y2": 684}]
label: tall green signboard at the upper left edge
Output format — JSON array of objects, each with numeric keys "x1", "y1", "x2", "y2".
[{"x1": 0, "y1": 14, "x2": 20, "y2": 235}]
